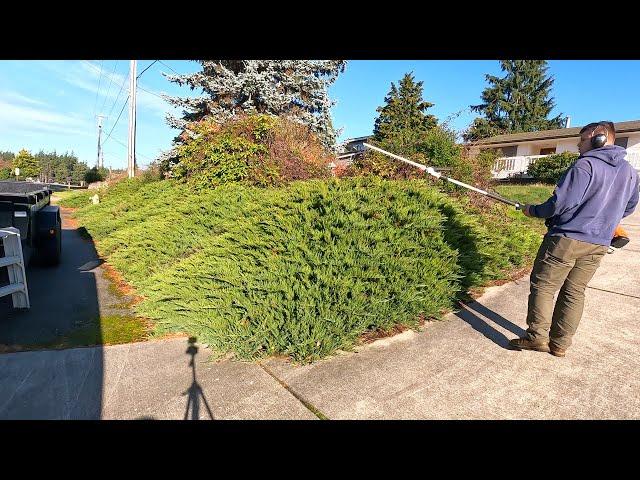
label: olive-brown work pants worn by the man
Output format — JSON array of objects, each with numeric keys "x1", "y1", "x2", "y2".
[{"x1": 527, "y1": 235, "x2": 608, "y2": 349}]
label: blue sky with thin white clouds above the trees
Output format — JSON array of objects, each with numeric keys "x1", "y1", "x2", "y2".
[{"x1": 0, "y1": 60, "x2": 640, "y2": 168}]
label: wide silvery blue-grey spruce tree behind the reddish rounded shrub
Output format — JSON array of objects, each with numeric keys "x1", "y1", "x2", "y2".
[{"x1": 165, "y1": 60, "x2": 346, "y2": 147}]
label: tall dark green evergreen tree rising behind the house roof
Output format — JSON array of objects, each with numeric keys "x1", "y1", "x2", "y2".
[{"x1": 464, "y1": 60, "x2": 563, "y2": 141}]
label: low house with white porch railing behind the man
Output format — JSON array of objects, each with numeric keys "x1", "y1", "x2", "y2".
[{"x1": 471, "y1": 120, "x2": 640, "y2": 179}]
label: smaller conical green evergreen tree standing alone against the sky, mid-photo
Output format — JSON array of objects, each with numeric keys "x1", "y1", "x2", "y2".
[{"x1": 373, "y1": 73, "x2": 438, "y2": 153}]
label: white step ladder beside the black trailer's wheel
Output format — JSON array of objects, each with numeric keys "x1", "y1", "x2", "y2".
[{"x1": 0, "y1": 227, "x2": 31, "y2": 308}]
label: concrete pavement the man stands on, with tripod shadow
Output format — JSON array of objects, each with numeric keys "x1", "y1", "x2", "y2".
[{"x1": 0, "y1": 212, "x2": 640, "y2": 419}]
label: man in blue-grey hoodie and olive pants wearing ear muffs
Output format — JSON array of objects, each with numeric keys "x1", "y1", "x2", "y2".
[{"x1": 509, "y1": 122, "x2": 639, "y2": 357}]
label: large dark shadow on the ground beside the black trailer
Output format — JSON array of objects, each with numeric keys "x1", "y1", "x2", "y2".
[{"x1": 0, "y1": 216, "x2": 104, "y2": 419}]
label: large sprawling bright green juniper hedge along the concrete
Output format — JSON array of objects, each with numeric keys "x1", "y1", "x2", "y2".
[{"x1": 58, "y1": 177, "x2": 539, "y2": 362}]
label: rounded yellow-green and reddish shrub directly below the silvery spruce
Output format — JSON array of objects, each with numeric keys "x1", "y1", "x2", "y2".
[{"x1": 161, "y1": 115, "x2": 333, "y2": 186}]
